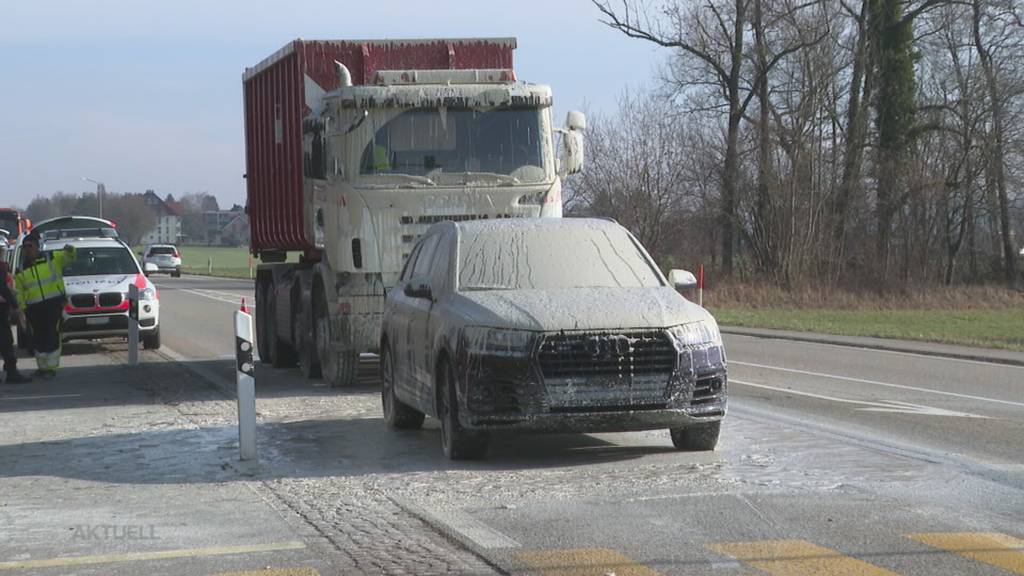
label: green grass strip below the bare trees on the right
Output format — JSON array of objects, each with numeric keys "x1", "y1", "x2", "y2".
[{"x1": 709, "y1": 306, "x2": 1024, "y2": 352}]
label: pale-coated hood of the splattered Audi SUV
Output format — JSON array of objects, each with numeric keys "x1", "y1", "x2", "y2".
[{"x1": 453, "y1": 286, "x2": 711, "y2": 332}]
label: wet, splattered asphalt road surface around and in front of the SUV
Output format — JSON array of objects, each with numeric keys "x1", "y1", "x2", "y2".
[{"x1": 0, "y1": 277, "x2": 1024, "y2": 575}]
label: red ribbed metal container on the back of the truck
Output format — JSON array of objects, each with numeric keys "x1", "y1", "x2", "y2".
[{"x1": 243, "y1": 38, "x2": 516, "y2": 253}]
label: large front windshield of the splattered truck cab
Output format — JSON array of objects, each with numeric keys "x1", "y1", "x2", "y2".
[{"x1": 359, "y1": 108, "x2": 546, "y2": 184}]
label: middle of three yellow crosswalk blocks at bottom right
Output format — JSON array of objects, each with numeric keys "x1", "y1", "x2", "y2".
[{"x1": 708, "y1": 540, "x2": 897, "y2": 576}]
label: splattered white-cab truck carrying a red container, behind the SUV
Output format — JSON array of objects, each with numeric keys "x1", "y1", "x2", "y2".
[{"x1": 243, "y1": 38, "x2": 586, "y2": 386}]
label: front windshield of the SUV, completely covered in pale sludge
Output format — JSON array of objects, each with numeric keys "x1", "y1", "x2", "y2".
[{"x1": 459, "y1": 224, "x2": 662, "y2": 291}]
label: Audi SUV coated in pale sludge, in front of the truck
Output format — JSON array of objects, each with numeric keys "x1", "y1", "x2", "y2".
[{"x1": 380, "y1": 218, "x2": 726, "y2": 458}]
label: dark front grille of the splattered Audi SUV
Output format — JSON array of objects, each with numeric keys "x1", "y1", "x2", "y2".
[{"x1": 539, "y1": 330, "x2": 678, "y2": 412}]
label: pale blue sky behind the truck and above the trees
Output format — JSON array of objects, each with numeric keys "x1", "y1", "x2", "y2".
[{"x1": 0, "y1": 0, "x2": 666, "y2": 206}]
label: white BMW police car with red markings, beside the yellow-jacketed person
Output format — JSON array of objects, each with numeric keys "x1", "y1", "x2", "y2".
[{"x1": 43, "y1": 238, "x2": 160, "y2": 349}]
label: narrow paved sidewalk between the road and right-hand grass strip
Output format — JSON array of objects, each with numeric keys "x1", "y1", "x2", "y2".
[{"x1": 721, "y1": 326, "x2": 1024, "y2": 366}]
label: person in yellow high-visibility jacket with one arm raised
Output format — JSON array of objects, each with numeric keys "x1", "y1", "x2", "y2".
[{"x1": 14, "y1": 235, "x2": 78, "y2": 378}]
